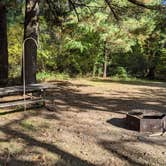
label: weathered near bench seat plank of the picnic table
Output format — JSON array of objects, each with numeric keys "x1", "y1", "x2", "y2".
[{"x1": 0, "y1": 99, "x2": 44, "y2": 108}]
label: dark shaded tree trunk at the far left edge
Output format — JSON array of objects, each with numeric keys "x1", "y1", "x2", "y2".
[{"x1": 0, "y1": 3, "x2": 8, "y2": 84}]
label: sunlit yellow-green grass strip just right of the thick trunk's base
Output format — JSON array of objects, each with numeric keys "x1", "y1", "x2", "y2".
[{"x1": 37, "y1": 72, "x2": 70, "y2": 81}]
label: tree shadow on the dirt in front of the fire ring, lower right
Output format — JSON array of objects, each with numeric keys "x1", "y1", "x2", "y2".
[{"x1": 99, "y1": 139, "x2": 166, "y2": 166}]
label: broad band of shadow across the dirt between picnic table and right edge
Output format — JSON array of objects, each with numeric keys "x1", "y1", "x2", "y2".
[{"x1": 44, "y1": 80, "x2": 166, "y2": 113}]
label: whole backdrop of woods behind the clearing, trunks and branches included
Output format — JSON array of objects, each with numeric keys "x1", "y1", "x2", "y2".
[{"x1": 0, "y1": 0, "x2": 166, "y2": 83}]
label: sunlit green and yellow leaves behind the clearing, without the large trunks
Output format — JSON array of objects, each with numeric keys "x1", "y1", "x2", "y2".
[{"x1": 8, "y1": 0, "x2": 166, "y2": 81}]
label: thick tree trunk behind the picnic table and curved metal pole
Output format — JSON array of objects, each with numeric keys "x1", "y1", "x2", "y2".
[{"x1": 24, "y1": 0, "x2": 39, "y2": 84}]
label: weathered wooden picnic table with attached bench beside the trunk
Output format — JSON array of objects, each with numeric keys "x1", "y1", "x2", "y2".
[{"x1": 0, "y1": 84, "x2": 50, "y2": 109}]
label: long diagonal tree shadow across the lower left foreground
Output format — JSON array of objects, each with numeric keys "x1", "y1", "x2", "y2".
[{"x1": 0, "y1": 115, "x2": 93, "y2": 166}]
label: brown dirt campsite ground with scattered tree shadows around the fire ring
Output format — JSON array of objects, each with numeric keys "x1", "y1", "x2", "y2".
[{"x1": 0, "y1": 79, "x2": 166, "y2": 166}]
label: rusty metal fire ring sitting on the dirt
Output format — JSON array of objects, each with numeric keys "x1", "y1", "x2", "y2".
[{"x1": 126, "y1": 110, "x2": 166, "y2": 132}]
